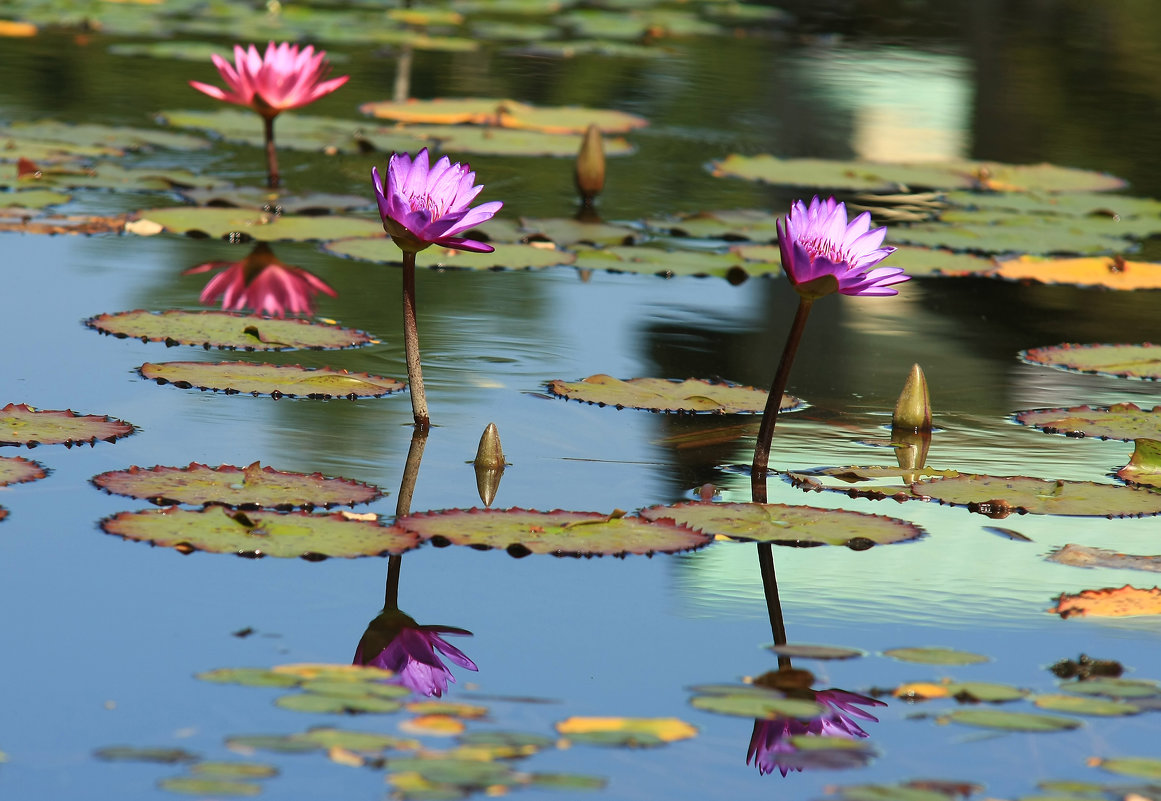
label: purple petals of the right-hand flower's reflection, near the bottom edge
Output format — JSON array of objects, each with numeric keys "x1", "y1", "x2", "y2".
[{"x1": 745, "y1": 690, "x2": 887, "y2": 775}]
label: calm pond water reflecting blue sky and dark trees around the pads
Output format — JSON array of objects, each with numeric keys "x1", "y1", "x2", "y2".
[{"x1": 0, "y1": 0, "x2": 1161, "y2": 800}]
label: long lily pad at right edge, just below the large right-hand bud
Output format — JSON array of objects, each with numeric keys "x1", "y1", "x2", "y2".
[{"x1": 910, "y1": 474, "x2": 1161, "y2": 518}]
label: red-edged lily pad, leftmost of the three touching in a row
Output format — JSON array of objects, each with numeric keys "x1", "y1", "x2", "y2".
[{"x1": 100, "y1": 505, "x2": 419, "y2": 561}]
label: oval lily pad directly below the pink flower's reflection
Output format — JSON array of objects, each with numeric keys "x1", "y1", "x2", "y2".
[{"x1": 85, "y1": 309, "x2": 378, "y2": 351}]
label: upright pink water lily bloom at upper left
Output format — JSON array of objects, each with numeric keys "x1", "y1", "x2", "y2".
[{"x1": 189, "y1": 42, "x2": 349, "y2": 118}]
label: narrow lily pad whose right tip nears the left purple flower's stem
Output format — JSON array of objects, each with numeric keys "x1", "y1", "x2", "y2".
[{"x1": 137, "y1": 361, "x2": 406, "y2": 399}]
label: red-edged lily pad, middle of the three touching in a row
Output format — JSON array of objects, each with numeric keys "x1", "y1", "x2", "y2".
[{"x1": 395, "y1": 508, "x2": 711, "y2": 557}]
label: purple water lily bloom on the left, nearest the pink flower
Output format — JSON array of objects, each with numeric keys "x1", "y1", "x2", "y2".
[{"x1": 370, "y1": 147, "x2": 504, "y2": 253}]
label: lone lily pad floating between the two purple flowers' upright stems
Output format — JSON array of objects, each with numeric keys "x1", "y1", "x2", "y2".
[{"x1": 548, "y1": 374, "x2": 802, "y2": 414}]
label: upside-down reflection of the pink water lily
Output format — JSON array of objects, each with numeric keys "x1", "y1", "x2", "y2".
[{"x1": 185, "y1": 243, "x2": 337, "y2": 317}]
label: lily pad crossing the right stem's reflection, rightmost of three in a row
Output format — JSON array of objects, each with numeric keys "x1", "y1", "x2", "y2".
[{"x1": 640, "y1": 501, "x2": 925, "y2": 550}]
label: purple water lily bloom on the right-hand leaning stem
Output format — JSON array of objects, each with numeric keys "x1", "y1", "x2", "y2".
[{"x1": 778, "y1": 196, "x2": 909, "y2": 298}]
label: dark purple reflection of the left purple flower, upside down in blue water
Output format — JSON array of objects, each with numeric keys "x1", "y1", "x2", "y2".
[{"x1": 354, "y1": 608, "x2": 478, "y2": 698}]
